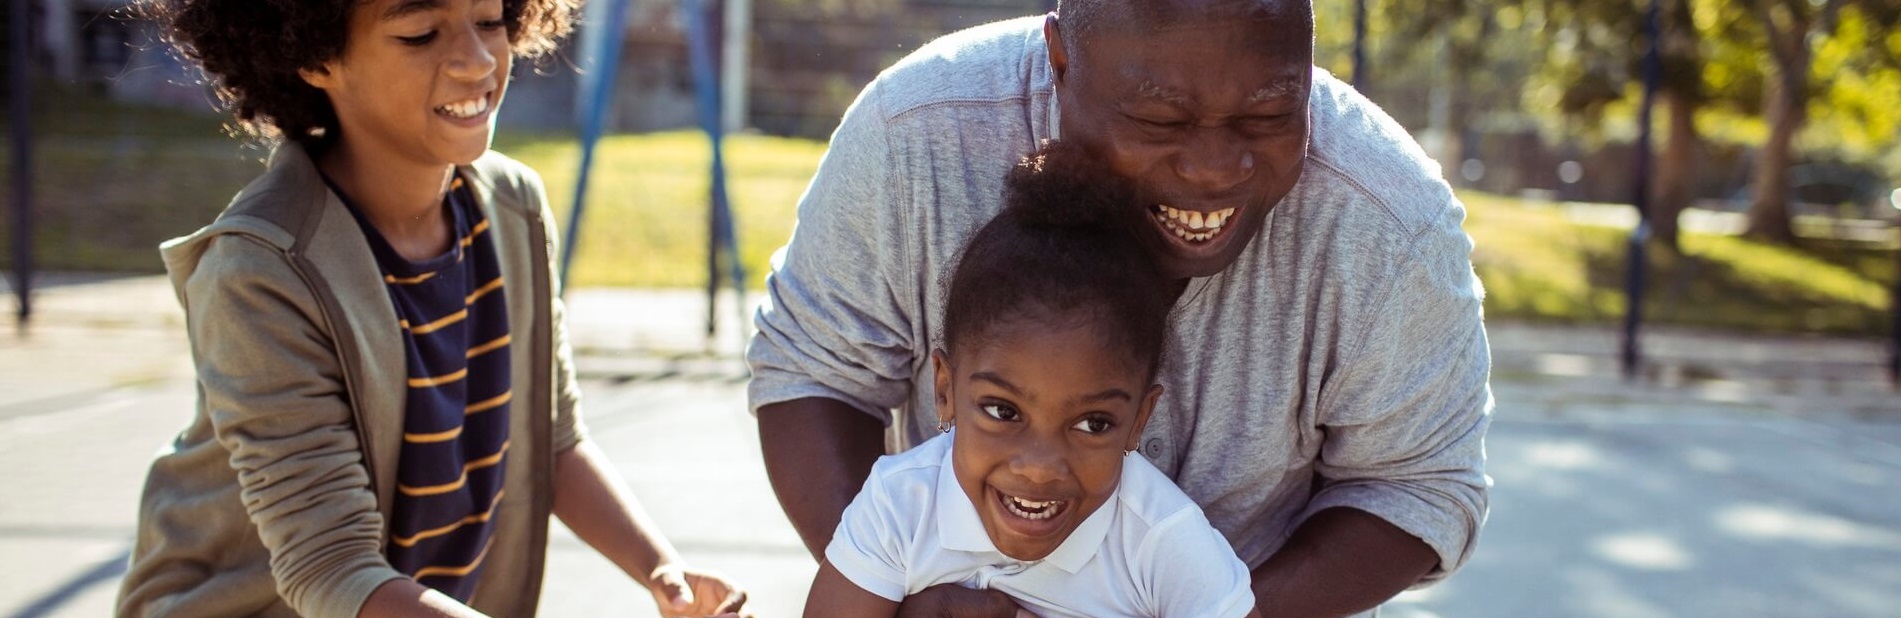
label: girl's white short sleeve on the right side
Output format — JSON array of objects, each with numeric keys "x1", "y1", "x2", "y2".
[{"x1": 1133, "y1": 508, "x2": 1255, "y2": 618}]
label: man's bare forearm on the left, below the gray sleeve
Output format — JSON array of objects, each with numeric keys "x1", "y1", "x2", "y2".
[{"x1": 758, "y1": 397, "x2": 884, "y2": 561}]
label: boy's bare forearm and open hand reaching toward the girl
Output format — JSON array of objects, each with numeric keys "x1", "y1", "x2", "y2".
[{"x1": 555, "y1": 441, "x2": 745, "y2": 616}]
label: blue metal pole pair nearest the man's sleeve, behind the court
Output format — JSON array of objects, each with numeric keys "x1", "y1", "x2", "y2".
[{"x1": 684, "y1": 0, "x2": 745, "y2": 337}]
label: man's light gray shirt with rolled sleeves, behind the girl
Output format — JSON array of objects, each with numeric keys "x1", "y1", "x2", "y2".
[{"x1": 747, "y1": 17, "x2": 1490, "y2": 578}]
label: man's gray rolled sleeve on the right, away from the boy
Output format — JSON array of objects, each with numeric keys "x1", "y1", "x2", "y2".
[{"x1": 1302, "y1": 203, "x2": 1492, "y2": 584}]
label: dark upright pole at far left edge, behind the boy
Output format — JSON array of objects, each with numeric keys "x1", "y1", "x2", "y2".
[{"x1": 6, "y1": 0, "x2": 32, "y2": 331}]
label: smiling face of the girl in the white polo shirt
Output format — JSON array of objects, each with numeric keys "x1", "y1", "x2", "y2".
[{"x1": 931, "y1": 319, "x2": 1162, "y2": 561}]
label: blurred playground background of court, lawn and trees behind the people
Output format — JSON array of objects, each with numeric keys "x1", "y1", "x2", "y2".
[{"x1": 0, "y1": 0, "x2": 1901, "y2": 616}]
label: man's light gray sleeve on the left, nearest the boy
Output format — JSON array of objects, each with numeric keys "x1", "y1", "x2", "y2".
[{"x1": 747, "y1": 73, "x2": 924, "y2": 424}]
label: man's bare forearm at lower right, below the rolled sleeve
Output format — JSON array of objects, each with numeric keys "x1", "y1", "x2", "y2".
[{"x1": 1255, "y1": 508, "x2": 1439, "y2": 618}]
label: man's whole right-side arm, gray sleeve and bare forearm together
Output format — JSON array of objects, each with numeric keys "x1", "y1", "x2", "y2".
[{"x1": 1253, "y1": 202, "x2": 1490, "y2": 616}]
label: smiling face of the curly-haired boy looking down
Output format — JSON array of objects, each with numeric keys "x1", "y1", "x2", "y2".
[{"x1": 302, "y1": 0, "x2": 511, "y2": 165}]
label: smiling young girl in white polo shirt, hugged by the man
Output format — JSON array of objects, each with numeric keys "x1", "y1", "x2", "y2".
[{"x1": 806, "y1": 145, "x2": 1255, "y2": 618}]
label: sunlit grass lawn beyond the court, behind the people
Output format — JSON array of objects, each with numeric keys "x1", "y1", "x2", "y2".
[{"x1": 0, "y1": 88, "x2": 1897, "y2": 335}]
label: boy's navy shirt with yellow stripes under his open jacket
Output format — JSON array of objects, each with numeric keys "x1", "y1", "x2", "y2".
[{"x1": 333, "y1": 177, "x2": 511, "y2": 603}]
